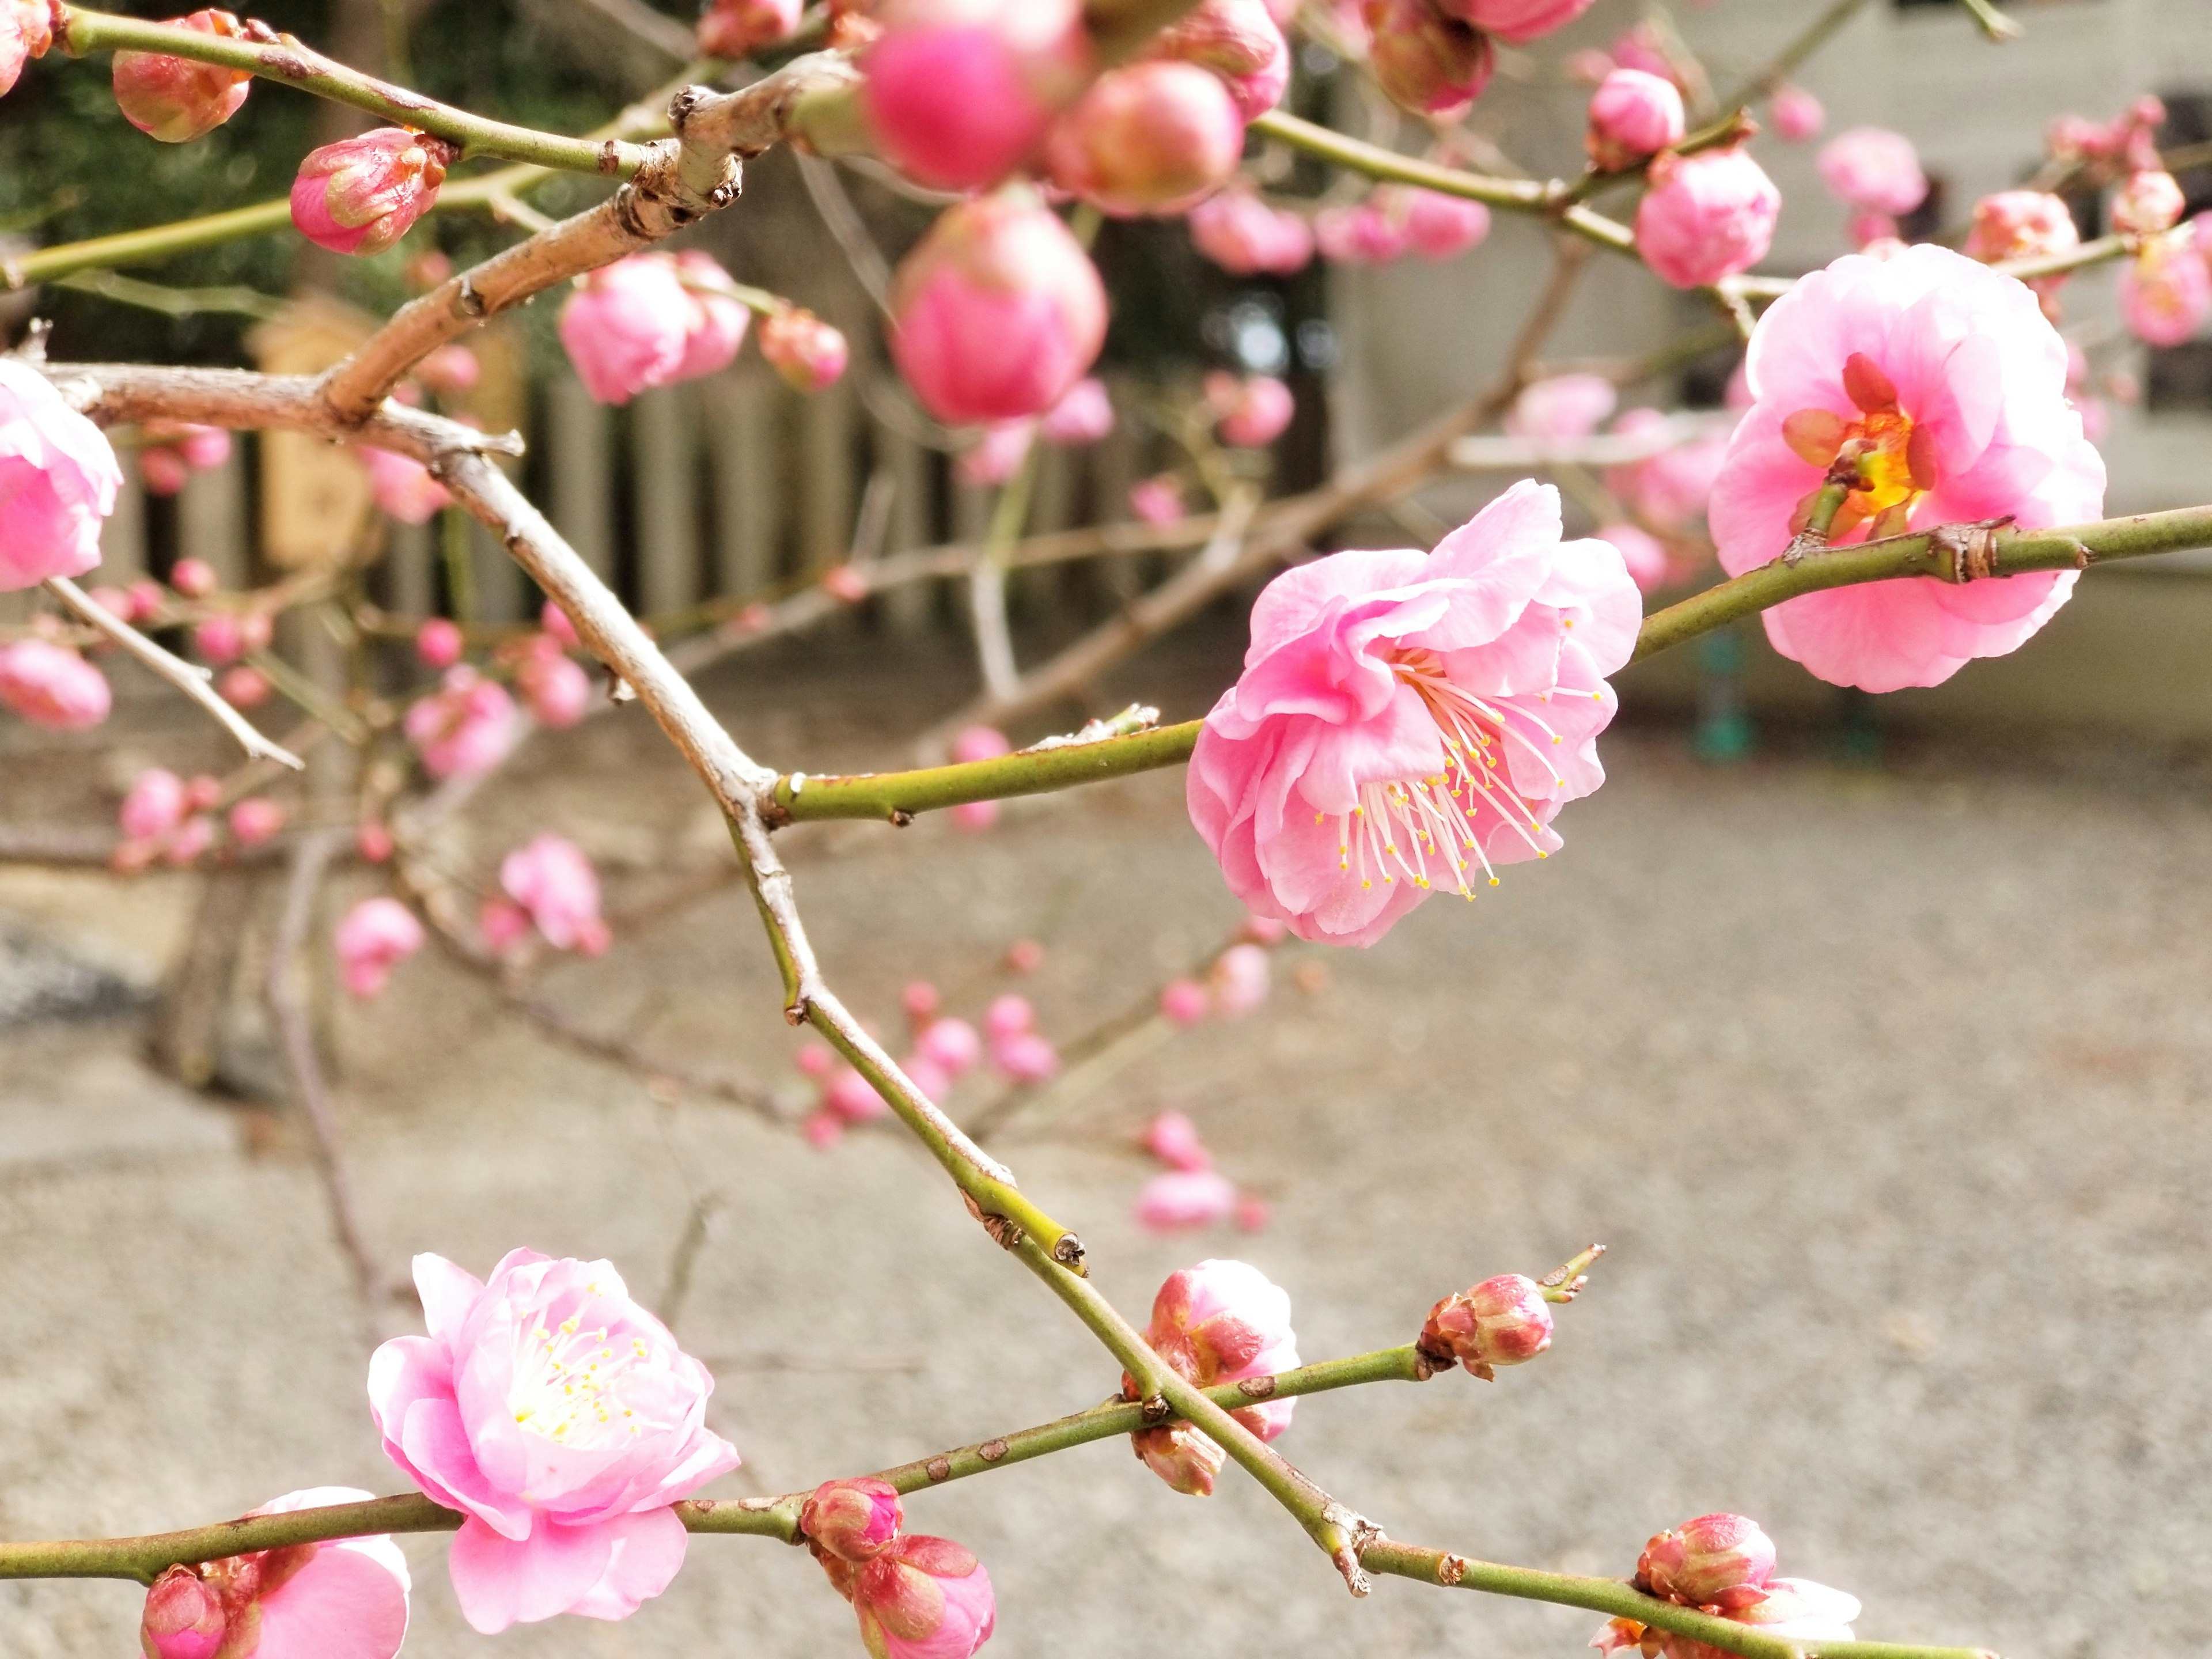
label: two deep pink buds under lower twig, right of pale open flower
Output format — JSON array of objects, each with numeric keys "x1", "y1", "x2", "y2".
[{"x1": 798, "y1": 1475, "x2": 998, "y2": 1659}]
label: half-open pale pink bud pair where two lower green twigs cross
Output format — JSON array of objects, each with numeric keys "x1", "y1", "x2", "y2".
[{"x1": 1122, "y1": 1256, "x2": 1298, "y2": 1498}]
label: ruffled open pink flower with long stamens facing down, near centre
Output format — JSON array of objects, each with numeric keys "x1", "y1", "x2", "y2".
[{"x1": 1188, "y1": 480, "x2": 1643, "y2": 945}]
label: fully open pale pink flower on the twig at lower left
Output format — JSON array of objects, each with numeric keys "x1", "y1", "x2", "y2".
[{"x1": 369, "y1": 1250, "x2": 739, "y2": 1635}]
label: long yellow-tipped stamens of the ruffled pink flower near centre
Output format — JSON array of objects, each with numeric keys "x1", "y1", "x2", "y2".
[{"x1": 1314, "y1": 650, "x2": 1601, "y2": 898}]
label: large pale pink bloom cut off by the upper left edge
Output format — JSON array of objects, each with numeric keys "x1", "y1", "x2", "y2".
[{"x1": 0, "y1": 356, "x2": 124, "y2": 593}]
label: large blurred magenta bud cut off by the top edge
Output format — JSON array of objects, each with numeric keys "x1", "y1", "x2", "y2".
[{"x1": 861, "y1": 0, "x2": 1093, "y2": 191}]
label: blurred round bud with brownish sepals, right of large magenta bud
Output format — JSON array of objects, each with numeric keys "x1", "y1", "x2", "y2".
[{"x1": 1046, "y1": 62, "x2": 1243, "y2": 219}]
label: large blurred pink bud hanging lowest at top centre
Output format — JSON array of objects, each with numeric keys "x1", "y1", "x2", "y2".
[{"x1": 892, "y1": 188, "x2": 1106, "y2": 425}]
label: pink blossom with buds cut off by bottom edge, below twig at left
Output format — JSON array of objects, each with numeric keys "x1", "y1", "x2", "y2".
[{"x1": 139, "y1": 1486, "x2": 411, "y2": 1659}]
